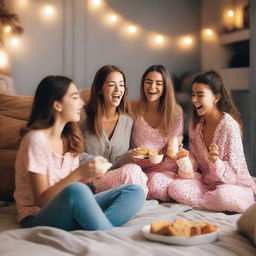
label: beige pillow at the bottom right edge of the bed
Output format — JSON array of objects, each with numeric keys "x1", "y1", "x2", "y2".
[{"x1": 237, "y1": 203, "x2": 256, "y2": 245}]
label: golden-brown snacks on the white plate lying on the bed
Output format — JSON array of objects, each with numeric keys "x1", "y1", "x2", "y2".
[{"x1": 150, "y1": 219, "x2": 217, "y2": 237}]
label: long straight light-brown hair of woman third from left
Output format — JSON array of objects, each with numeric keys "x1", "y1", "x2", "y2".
[{"x1": 139, "y1": 65, "x2": 180, "y2": 135}]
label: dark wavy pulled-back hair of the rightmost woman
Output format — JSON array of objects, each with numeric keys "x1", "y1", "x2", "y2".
[{"x1": 192, "y1": 70, "x2": 243, "y2": 136}]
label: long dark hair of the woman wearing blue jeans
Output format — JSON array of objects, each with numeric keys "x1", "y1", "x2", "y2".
[{"x1": 21, "y1": 76, "x2": 84, "y2": 156}]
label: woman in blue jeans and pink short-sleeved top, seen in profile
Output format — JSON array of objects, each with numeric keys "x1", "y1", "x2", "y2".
[{"x1": 14, "y1": 76, "x2": 145, "y2": 230}]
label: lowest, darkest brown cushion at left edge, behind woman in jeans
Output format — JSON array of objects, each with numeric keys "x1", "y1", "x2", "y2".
[{"x1": 0, "y1": 150, "x2": 16, "y2": 201}]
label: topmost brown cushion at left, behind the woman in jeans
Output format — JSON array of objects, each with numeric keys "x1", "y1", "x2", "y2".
[{"x1": 0, "y1": 94, "x2": 33, "y2": 120}]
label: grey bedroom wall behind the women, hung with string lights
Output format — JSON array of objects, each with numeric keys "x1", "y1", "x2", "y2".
[{"x1": 9, "y1": 0, "x2": 201, "y2": 99}]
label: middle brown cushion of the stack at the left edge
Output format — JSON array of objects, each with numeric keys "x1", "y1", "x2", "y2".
[{"x1": 0, "y1": 115, "x2": 27, "y2": 149}]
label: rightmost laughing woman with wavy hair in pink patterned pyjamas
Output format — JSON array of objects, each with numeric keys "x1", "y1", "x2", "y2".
[{"x1": 169, "y1": 71, "x2": 256, "y2": 213}]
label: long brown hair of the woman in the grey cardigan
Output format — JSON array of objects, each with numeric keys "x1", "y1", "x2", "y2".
[{"x1": 85, "y1": 65, "x2": 131, "y2": 138}]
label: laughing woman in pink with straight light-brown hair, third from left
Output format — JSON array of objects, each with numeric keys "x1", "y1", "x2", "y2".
[{"x1": 132, "y1": 65, "x2": 186, "y2": 201}]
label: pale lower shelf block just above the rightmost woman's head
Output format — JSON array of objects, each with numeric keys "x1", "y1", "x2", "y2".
[{"x1": 218, "y1": 68, "x2": 250, "y2": 91}]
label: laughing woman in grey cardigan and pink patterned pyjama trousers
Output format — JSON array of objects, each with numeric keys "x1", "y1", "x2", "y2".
[{"x1": 80, "y1": 65, "x2": 148, "y2": 194}]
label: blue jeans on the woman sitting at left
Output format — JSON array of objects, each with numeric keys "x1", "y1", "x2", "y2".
[{"x1": 21, "y1": 182, "x2": 145, "y2": 231}]
